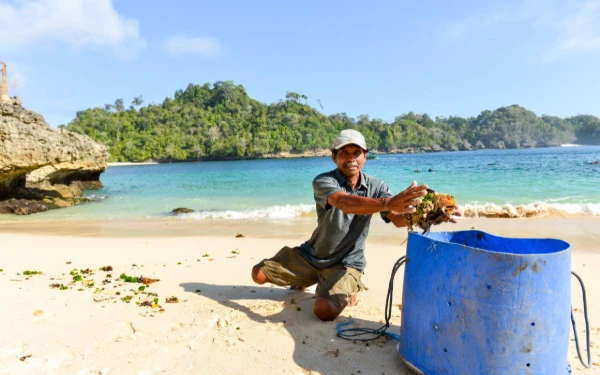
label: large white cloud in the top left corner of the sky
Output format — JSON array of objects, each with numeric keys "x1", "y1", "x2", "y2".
[{"x1": 0, "y1": 0, "x2": 145, "y2": 58}]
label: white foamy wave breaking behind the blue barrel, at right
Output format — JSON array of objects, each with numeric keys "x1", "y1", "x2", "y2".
[{"x1": 462, "y1": 202, "x2": 600, "y2": 218}]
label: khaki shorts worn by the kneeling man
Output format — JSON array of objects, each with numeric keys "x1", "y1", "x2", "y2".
[{"x1": 258, "y1": 246, "x2": 366, "y2": 308}]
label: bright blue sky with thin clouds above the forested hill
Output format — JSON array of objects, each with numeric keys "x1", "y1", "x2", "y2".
[{"x1": 0, "y1": 0, "x2": 600, "y2": 126}]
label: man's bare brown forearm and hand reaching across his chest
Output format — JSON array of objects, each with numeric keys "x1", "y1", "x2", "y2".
[{"x1": 327, "y1": 181, "x2": 427, "y2": 216}]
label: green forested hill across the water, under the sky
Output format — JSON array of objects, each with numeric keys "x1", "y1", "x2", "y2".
[{"x1": 60, "y1": 81, "x2": 600, "y2": 162}]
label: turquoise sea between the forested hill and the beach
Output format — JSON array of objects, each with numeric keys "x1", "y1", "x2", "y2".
[{"x1": 0, "y1": 146, "x2": 600, "y2": 221}]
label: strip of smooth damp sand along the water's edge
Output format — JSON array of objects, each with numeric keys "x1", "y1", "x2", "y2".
[{"x1": 0, "y1": 215, "x2": 600, "y2": 245}]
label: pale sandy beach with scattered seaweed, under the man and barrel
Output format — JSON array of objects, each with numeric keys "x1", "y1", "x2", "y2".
[{"x1": 0, "y1": 217, "x2": 600, "y2": 375}]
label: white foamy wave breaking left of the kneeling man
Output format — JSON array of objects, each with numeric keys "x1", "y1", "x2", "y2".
[{"x1": 177, "y1": 204, "x2": 315, "y2": 220}]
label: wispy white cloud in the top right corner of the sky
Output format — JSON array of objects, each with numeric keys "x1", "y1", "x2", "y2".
[{"x1": 441, "y1": 0, "x2": 600, "y2": 61}]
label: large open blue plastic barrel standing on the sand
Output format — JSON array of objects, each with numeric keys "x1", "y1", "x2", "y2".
[{"x1": 398, "y1": 230, "x2": 571, "y2": 375}]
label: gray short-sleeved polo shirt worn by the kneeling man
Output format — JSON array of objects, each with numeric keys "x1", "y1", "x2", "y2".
[{"x1": 300, "y1": 169, "x2": 393, "y2": 272}]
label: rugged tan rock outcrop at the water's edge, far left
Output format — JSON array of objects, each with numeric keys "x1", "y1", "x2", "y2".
[{"x1": 0, "y1": 97, "x2": 108, "y2": 215}]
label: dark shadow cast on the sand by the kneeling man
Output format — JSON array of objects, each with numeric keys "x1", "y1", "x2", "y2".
[{"x1": 180, "y1": 282, "x2": 413, "y2": 375}]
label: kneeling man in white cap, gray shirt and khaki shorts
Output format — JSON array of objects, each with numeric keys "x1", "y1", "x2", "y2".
[{"x1": 252, "y1": 129, "x2": 454, "y2": 321}]
